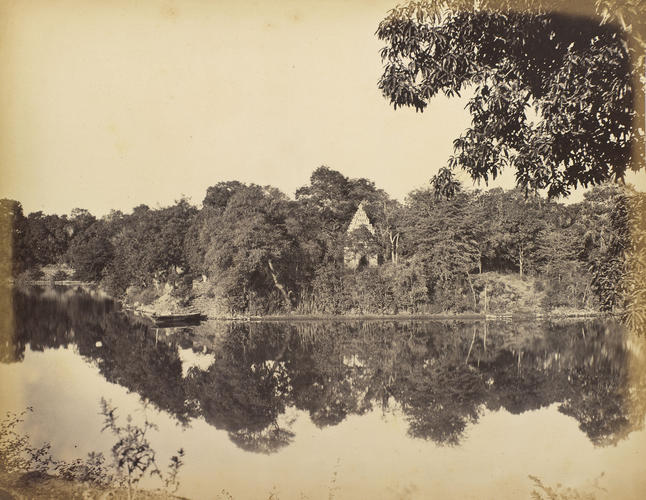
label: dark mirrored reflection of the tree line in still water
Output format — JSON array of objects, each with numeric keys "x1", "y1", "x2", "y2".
[{"x1": 5, "y1": 290, "x2": 646, "y2": 453}]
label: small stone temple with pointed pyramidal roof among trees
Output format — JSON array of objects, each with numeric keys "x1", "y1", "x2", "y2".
[{"x1": 343, "y1": 201, "x2": 379, "y2": 269}]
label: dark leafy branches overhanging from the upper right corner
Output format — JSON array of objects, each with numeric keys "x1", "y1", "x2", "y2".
[{"x1": 377, "y1": 0, "x2": 646, "y2": 197}]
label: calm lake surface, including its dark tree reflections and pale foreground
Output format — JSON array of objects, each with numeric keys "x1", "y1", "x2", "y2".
[{"x1": 0, "y1": 289, "x2": 646, "y2": 499}]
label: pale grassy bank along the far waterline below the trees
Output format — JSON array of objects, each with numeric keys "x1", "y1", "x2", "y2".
[{"x1": 19, "y1": 266, "x2": 603, "y2": 321}]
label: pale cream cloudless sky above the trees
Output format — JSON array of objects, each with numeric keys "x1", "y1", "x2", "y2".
[{"x1": 0, "y1": 0, "x2": 644, "y2": 215}]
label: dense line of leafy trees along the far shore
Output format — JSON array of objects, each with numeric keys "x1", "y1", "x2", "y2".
[{"x1": 2, "y1": 167, "x2": 644, "y2": 318}]
